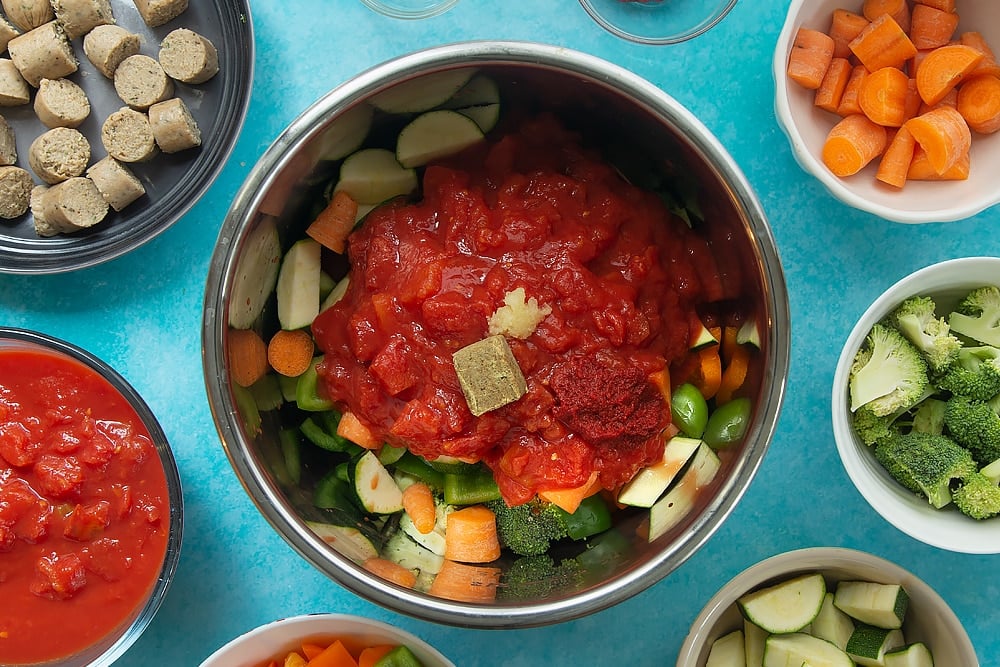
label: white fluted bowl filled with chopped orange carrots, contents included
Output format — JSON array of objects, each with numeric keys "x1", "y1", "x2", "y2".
[{"x1": 773, "y1": 0, "x2": 1000, "y2": 223}]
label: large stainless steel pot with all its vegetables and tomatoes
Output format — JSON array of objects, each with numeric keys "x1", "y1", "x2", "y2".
[{"x1": 203, "y1": 42, "x2": 789, "y2": 628}]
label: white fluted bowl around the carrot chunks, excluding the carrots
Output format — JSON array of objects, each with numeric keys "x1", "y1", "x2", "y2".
[{"x1": 773, "y1": 0, "x2": 1000, "y2": 223}]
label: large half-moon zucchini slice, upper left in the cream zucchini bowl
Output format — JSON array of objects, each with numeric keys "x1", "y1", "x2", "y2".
[{"x1": 736, "y1": 573, "x2": 826, "y2": 633}]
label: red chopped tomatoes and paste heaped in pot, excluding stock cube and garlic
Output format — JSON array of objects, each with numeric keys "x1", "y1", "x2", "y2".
[{"x1": 313, "y1": 116, "x2": 715, "y2": 503}]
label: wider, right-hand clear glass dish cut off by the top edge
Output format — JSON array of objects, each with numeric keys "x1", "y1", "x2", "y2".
[{"x1": 580, "y1": 0, "x2": 736, "y2": 45}]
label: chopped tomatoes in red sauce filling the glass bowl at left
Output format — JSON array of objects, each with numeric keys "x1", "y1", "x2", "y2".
[{"x1": 0, "y1": 350, "x2": 170, "y2": 665}]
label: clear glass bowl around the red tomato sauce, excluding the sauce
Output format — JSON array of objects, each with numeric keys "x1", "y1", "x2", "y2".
[{"x1": 0, "y1": 327, "x2": 184, "y2": 667}]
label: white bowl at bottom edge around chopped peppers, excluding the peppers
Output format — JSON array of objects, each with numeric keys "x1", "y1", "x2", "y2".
[{"x1": 201, "y1": 614, "x2": 455, "y2": 667}]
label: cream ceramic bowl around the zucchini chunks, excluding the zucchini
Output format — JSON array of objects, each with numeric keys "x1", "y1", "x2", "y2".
[{"x1": 677, "y1": 547, "x2": 979, "y2": 667}]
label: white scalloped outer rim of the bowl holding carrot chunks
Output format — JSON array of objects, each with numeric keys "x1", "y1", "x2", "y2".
[{"x1": 772, "y1": 0, "x2": 1000, "y2": 224}]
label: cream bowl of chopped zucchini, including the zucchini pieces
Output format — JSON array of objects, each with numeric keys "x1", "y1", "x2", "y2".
[{"x1": 677, "y1": 547, "x2": 979, "y2": 667}]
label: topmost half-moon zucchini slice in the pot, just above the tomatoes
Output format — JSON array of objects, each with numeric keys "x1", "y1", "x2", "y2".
[{"x1": 396, "y1": 109, "x2": 486, "y2": 169}]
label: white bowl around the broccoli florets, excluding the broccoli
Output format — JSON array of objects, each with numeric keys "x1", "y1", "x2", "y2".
[{"x1": 833, "y1": 257, "x2": 1000, "y2": 554}]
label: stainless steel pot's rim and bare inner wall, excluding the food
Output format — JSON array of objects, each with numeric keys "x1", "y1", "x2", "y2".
[{"x1": 202, "y1": 42, "x2": 790, "y2": 628}]
